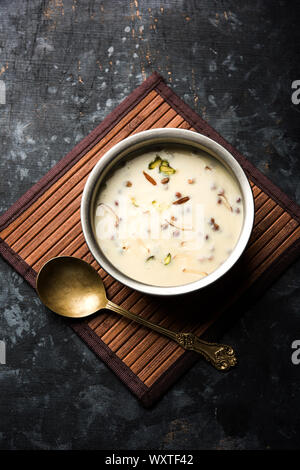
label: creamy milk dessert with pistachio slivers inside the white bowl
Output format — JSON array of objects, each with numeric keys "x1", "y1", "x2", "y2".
[{"x1": 94, "y1": 146, "x2": 243, "y2": 286}]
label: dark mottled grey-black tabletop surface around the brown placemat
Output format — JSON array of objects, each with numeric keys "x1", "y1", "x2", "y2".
[{"x1": 0, "y1": 0, "x2": 300, "y2": 450}]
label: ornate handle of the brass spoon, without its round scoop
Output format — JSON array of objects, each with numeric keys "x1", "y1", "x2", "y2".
[{"x1": 106, "y1": 300, "x2": 237, "y2": 370}]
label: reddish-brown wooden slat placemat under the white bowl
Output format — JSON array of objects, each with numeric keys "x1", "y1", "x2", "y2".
[{"x1": 0, "y1": 73, "x2": 300, "y2": 406}]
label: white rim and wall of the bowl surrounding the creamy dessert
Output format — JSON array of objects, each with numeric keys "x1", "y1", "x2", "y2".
[{"x1": 80, "y1": 128, "x2": 254, "y2": 296}]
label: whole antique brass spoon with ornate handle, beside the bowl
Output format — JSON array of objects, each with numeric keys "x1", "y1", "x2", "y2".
[{"x1": 36, "y1": 256, "x2": 236, "y2": 370}]
